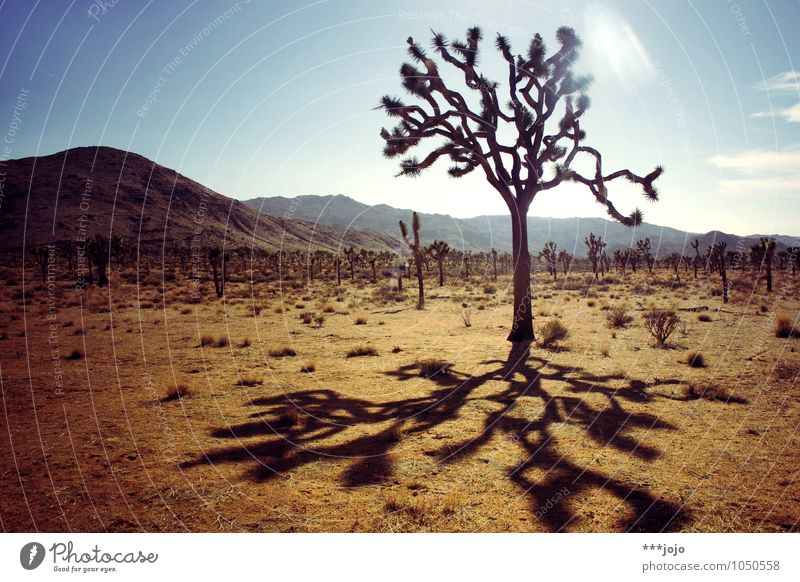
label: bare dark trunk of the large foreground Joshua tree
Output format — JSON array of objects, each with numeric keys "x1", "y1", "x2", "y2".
[{"x1": 508, "y1": 209, "x2": 536, "y2": 344}]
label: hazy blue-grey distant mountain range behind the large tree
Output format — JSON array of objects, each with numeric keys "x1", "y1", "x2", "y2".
[{"x1": 244, "y1": 194, "x2": 798, "y2": 256}]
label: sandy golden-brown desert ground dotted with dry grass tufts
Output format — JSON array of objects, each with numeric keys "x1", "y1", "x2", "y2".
[{"x1": 0, "y1": 268, "x2": 800, "y2": 532}]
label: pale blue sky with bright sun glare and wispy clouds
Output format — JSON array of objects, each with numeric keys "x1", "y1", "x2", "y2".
[{"x1": 0, "y1": 0, "x2": 800, "y2": 235}]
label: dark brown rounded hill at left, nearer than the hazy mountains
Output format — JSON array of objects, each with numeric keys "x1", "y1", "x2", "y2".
[{"x1": 0, "y1": 147, "x2": 398, "y2": 250}]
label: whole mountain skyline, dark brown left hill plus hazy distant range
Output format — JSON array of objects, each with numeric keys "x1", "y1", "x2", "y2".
[{"x1": 0, "y1": 147, "x2": 798, "y2": 256}]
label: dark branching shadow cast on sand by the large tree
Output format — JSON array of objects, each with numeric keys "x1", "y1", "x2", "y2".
[{"x1": 181, "y1": 346, "x2": 752, "y2": 532}]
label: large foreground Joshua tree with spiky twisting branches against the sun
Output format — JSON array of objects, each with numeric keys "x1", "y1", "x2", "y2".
[{"x1": 380, "y1": 27, "x2": 662, "y2": 345}]
